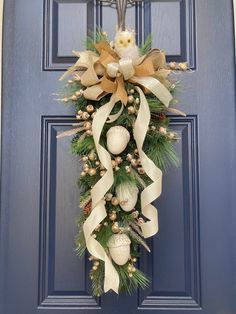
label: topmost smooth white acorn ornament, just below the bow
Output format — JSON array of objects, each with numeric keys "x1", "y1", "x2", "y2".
[{"x1": 107, "y1": 125, "x2": 130, "y2": 155}]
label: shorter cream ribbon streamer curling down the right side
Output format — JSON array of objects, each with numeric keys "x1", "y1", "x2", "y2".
[{"x1": 133, "y1": 86, "x2": 162, "y2": 238}]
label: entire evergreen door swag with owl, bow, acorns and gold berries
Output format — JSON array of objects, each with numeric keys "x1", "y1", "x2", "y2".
[{"x1": 58, "y1": 8, "x2": 187, "y2": 296}]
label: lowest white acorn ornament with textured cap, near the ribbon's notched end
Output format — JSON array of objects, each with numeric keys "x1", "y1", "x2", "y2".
[{"x1": 107, "y1": 233, "x2": 131, "y2": 265}]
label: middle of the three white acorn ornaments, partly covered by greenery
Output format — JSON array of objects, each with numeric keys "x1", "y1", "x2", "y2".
[{"x1": 116, "y1": 183, "x2": 138, "y2": 212}]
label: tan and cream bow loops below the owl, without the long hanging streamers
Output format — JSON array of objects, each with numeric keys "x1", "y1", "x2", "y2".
[{"x1": 60, "y1": 41, "x2": 172, "y2": 107}]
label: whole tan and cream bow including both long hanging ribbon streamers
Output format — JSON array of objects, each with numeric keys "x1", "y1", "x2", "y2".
[{"x1": 61, "y1": 42, "x2": 172, "y2": 293}]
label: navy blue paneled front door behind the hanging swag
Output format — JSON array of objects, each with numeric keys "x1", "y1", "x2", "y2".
[{"x1": 0, "y1": 0, "x2": 236, "y2": 314}]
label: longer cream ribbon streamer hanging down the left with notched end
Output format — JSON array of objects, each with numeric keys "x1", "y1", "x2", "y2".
[{"x1": 83, "y1": 94, "x2": 119, "y2": 294}]
